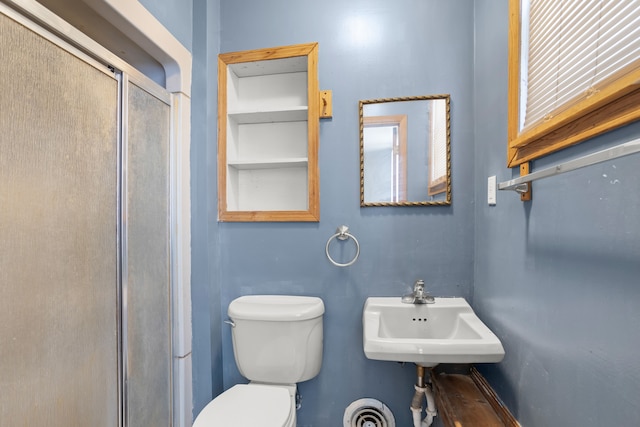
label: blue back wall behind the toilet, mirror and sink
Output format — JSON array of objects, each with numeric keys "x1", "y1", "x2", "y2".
[{"x1": 219, "y1": 0, "x2": 474, "y2": 427}]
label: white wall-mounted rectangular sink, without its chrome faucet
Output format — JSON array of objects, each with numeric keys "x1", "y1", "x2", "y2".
[{"x1": 362, "y1": 297, "x2": 504, "y2": 367}]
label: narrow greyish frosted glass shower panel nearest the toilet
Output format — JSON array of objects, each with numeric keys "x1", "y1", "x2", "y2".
[{"x1": 122, "y1": 83, "x2": 172, "y2": 427}]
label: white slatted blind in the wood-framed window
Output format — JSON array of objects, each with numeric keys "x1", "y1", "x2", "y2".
[{"x1": 519, "y1": 0, "x2": 640, "y2": 130}]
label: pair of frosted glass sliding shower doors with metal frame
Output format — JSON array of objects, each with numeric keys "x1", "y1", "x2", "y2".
[{"x1": 0, "y1": 4, "x2": 180, "y2": 427}]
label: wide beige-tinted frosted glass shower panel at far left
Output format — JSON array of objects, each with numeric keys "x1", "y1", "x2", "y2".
[{"x1": 0, "y1": 13, "x2": 119, "y2": 427}]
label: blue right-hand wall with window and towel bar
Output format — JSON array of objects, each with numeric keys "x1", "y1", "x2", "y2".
[{"x1": 474, "y1": 1, "x2": 640, "y2": 427}]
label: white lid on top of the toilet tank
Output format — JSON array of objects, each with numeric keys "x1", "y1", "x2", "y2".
[{"x1": 228, "y1": 295, "x2": 324, "y2": 322}]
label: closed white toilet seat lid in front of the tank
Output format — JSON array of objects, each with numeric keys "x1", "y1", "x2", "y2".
[{"x1": 193, "y1": 384, "x2": 295, "y2": 427}]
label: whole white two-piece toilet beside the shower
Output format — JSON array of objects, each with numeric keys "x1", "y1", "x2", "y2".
[{"x1": 193, "y1": 295, "x2": 324, "y2": 427}]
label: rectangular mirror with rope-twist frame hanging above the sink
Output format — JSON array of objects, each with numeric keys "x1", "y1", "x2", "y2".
[{"x1": 360, "y1": 95, "x2": 451, "y2": 206}]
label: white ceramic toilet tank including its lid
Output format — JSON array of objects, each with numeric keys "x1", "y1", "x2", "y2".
[{"x1": 228, "y1": 295, "x2": 324, "y2": 384}]
